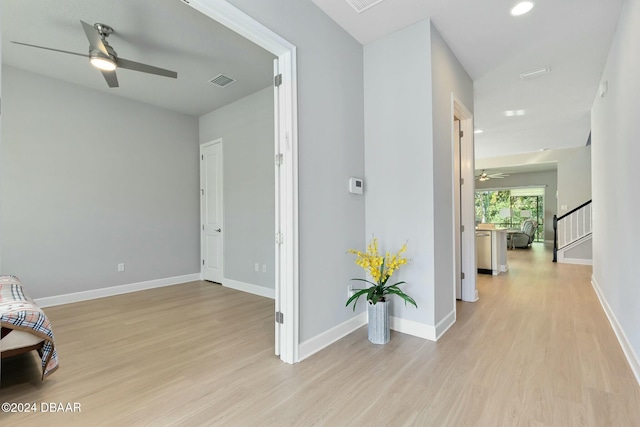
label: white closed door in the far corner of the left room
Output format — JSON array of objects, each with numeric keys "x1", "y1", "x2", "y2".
[{"x1": 200, "y1": 139, "x2": 223, "y2": 283}]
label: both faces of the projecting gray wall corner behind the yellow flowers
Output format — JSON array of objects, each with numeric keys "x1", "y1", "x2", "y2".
[{"x1": 365, "y1": 20, "x2": 473, "y2": 332}]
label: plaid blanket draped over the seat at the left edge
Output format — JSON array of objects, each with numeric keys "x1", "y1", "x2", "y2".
[{"x1": 0, "y1": 276, "x2": 58, "y2": 380}]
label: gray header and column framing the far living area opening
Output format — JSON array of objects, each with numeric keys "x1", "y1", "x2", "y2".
[{"x1": 476, "y1": 171, "x2": 556, "y2": 241}]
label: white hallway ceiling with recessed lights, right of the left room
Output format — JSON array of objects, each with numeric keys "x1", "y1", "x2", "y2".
[{"x1": 312, "y1": 0, "x2": 624, "y2": 158}]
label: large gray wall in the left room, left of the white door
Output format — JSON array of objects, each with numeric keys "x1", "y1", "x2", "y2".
[{"x1": 0, "y1": 67, "x2": 200, "y2": 298}]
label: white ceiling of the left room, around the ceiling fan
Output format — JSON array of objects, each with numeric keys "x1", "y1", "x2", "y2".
[{"x1": 0, "y1": 0, "x2": 274, "y2": 116}]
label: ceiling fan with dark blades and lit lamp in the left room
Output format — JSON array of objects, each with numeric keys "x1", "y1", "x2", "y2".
[{"x1": 11, "y1": 21, "x2": 178, "y2": 87}]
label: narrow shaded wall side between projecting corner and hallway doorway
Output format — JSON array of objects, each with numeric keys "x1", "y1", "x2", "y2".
[{"x1": 430, "y1": 23, "x2": 475, "y2": 324}]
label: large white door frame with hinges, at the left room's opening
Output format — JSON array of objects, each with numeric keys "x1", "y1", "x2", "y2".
[{"x1": 188, "y1": 0, "x2": 299, "y2": 363}]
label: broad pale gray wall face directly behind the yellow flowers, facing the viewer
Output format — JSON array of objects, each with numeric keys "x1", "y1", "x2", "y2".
[{"x1": 360, "y1": 20, "x2": 438, "y2": 327}]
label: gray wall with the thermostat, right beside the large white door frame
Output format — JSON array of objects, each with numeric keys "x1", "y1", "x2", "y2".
[{"x1": 229, "y1": 0, "x2": 365, "y2": 342}]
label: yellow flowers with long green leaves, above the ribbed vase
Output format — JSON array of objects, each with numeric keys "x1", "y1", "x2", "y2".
[{"x1": 346, "y1": 237, "x2": 418, "y2": 310}]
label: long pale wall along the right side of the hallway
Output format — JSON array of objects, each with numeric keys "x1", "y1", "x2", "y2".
[{"x1": 591, "y1": 0, "x2": 640, "y2": 381}]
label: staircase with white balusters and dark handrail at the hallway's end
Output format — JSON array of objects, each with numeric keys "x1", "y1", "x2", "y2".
[{"x1": 553, "y1": 200, "x2": 593, "y2": 265}]
